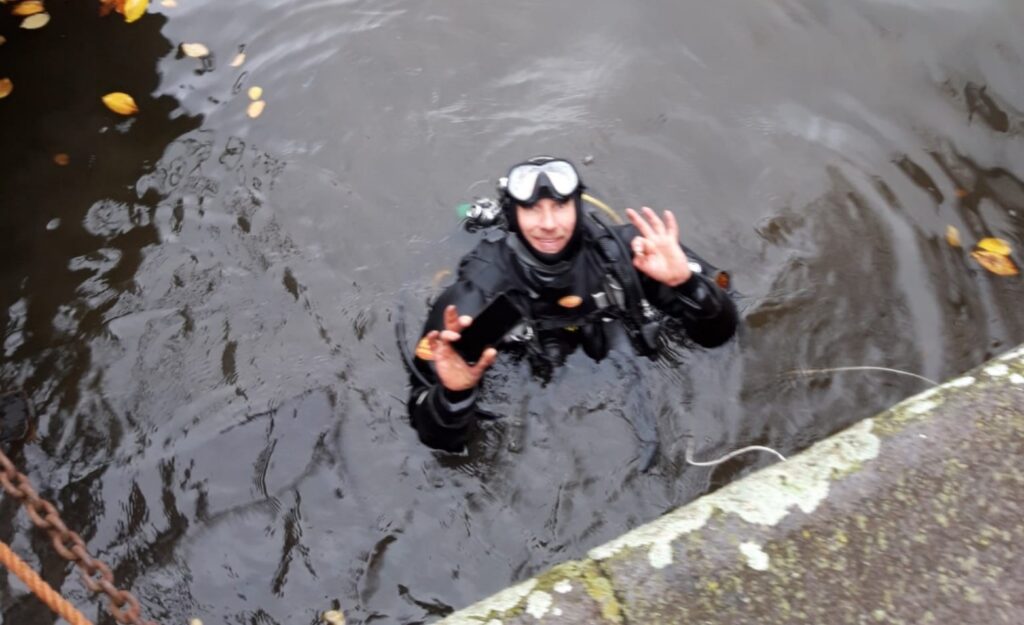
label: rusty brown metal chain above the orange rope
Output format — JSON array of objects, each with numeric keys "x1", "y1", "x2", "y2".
[{"x1": 0, "y1": 451, "x2": 157, "y2": 625}]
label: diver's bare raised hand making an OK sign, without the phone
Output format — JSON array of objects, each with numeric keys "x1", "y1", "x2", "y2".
[{"x1": 626, "y1": 206, "x2": 693, "y2": 287}]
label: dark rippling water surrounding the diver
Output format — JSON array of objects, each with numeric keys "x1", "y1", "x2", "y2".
[{"x1": 0, "y1": 0, "x2": 1024, "y2": 625}]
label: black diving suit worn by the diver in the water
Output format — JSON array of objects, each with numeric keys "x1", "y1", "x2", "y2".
[{"x1": 409, "y1": 214, "x2": 737, "y2": 451}]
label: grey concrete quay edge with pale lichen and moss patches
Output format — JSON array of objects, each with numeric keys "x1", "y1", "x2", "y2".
[{"x1": 440, "y1": 347, "x2": 1024, "y2": 625}]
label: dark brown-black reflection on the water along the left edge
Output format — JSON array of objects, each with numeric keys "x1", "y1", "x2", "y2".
[{"x1": 0, "y1": 2, "x2": 202, "y2": 623}]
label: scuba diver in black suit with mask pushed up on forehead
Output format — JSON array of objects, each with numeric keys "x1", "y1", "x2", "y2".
[{"x1": 406, "y1": 156, "x2": 737, "y2": 470}]
